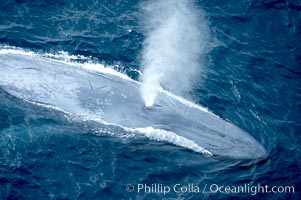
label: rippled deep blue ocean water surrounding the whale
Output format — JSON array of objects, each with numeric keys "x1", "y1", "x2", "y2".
[{"x1": 0, "y1": 0, "x2": 301, "y2": 199}]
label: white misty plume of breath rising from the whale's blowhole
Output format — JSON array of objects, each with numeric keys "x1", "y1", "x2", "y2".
[{"x1": 140, "y1": 0, "x2": 209, "y2": 106}]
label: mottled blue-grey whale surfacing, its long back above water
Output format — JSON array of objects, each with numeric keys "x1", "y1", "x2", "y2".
[{"x1": 0, "y1": 48, "x2": 266, "y2": 159}]
